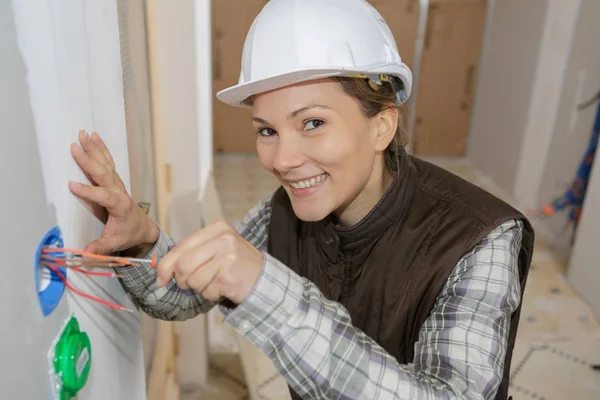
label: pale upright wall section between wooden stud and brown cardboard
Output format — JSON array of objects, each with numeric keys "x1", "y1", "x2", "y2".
[{"x1": 149, "y1": 0, "x2": 212, "y2": 389}]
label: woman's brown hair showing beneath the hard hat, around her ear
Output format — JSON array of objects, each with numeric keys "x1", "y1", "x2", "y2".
[{"x1": 333, "y1": 76, "x2": 409, "y2": 170}]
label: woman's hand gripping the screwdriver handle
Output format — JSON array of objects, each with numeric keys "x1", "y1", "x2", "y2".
[{"x1": 157, "y1": 221, "x2": 263, "y2": 304}]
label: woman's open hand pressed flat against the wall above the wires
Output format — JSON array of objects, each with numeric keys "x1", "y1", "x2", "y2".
[{"x1": 69, "y1": 131, "x2": 159, "y2": 254}]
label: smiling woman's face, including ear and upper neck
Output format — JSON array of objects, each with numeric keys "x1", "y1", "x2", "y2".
[{"x1": 252, "y1": 79, "x2": 398, "y2": 226}]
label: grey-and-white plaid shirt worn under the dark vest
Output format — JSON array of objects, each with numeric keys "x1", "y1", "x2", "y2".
[{"x1": 120, "y1": 195, "x2": 522, "y2": 400}]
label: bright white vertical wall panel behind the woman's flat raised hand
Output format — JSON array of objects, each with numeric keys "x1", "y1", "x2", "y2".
[{"x1": 12, "y1": 0, "x2": 145, "y2": 400}]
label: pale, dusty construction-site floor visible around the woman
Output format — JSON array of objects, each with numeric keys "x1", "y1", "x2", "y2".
[{"x1": 182, "y1": 155, "x2": 600, "y2": 400}]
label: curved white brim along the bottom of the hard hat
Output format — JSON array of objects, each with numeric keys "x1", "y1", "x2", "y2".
[{"x1": 217, "y1": 64, "x2": 412, "y2": 107}]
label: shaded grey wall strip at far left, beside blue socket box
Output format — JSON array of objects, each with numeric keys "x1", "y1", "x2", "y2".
[{"x1": 0, "y1": 0, "x2": 68, "y2": 399}]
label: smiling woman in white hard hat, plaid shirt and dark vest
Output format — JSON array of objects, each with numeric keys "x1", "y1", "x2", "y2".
[{"x1": 70, "y1": 0, "x2": 533, "y2": 399}]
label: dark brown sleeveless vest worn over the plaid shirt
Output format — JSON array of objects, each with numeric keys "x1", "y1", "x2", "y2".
[{"x1": 268, "y1": 148, "x2": 534, "y2": 399}]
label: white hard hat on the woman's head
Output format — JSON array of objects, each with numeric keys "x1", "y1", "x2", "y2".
[{"x1": 217, "y1": 0, "x2": 412, "y2": 106}]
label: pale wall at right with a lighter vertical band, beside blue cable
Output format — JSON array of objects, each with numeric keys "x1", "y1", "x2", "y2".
[{"x1": 469, "y1": 0, "x2": 600, "y2": 256}]
